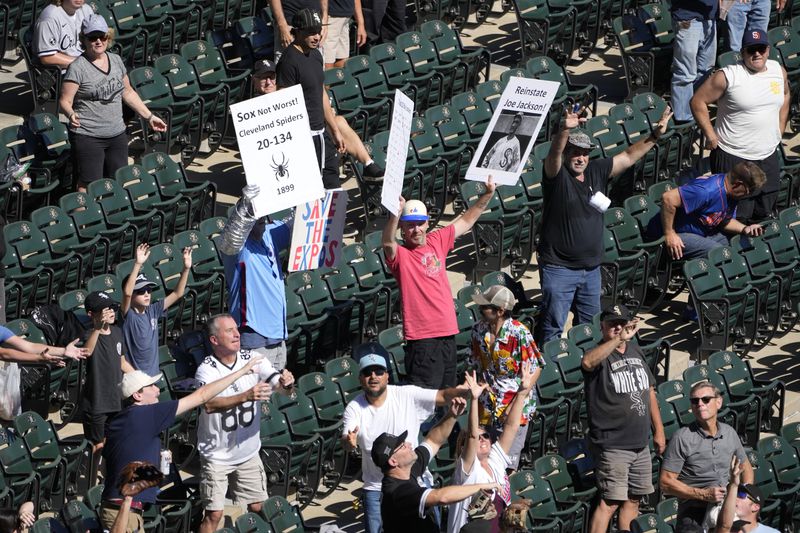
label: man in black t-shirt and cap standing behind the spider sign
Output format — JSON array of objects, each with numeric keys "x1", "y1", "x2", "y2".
[{"x1": 277, "y1": 8, "x2": 345, "y2": 189}]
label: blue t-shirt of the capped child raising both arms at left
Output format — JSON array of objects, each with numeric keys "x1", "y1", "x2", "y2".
[{"x1": 122, "y1": 300, "x2": 166, "y2": 376}]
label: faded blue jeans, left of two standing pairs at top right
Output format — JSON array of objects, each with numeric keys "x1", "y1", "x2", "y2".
[{"x1": 672, "y1": 19, "x2": 720, "y2": 121}]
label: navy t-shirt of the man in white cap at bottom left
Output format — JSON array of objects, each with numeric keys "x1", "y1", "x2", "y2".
[{"x1": 103, "y1": 400, "x2": 178, "y2": 503}]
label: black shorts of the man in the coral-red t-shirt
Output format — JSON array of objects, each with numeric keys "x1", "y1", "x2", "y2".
[{"x1": 405, "y1": 335, "x2": 456, "y2": 390}]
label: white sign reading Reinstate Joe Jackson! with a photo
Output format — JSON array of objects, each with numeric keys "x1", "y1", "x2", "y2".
[{"x1": 466, "y1": 77, "x2": 559, "y2": 185}]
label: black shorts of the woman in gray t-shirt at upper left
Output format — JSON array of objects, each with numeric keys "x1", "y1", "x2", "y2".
[{"x1": 69, "y1": 132, "x2": 128, "y2": 183}]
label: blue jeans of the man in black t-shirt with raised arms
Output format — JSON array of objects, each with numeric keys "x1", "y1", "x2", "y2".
[{"x1": 536, "y1": 265, "x2": 600, "y2": 348}]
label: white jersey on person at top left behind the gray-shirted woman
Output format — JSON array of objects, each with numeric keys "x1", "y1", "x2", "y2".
[{"x1": 33, "y1": 4, "x2": 94, "y2": 57}]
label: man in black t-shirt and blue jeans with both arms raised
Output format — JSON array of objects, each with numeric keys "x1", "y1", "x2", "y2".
[{"x1": 535, "y1": 106, "x2": 672, "y2": 346}]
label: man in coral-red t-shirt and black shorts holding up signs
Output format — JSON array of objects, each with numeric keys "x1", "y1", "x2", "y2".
[{"x1": 383, "y1": 176, "x2": 495, "y2": 389}]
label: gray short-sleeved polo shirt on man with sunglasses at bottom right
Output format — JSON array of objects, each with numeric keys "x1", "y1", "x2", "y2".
[{"x1": 661, "y1": 422, "x2": 747, "y2": 488}]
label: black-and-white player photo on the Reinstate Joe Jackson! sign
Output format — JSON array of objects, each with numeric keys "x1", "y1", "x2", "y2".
[{"x1": 478, "y1": 110, "x2": 542, "y2": 173}]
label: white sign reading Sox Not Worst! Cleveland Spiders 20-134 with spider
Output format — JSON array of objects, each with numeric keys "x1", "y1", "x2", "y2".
[{"x1": 230, "y1": 85, "x2": 325, "y2": 217}]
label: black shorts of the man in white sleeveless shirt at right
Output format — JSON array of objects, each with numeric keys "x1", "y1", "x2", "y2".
[{"x1": 711, "y1": 148, "x2": 781, "y2": 224}]
